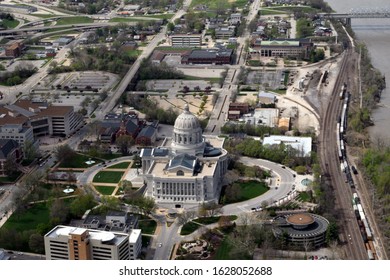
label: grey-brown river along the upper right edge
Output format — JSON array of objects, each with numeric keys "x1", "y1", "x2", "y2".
[{"x1": 327, "y1": 0, "x2": 390, "y2": 142}]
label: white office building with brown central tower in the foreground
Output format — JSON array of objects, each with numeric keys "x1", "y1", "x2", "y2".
[{"x1": 44, "y1": 226, "x2": 141, "y2": 260}]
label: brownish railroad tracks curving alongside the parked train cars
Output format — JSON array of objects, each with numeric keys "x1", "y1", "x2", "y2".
[{"x1": 319, "y1": 48, "x2": 367, "y2": 260}]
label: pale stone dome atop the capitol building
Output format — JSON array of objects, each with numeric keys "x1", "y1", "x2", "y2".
[{"x1": 171, "y1": 104, "x2": 205, "y2": 155}]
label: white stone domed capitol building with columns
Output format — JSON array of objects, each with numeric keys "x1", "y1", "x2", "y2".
[{"x1": 140, "y1": 104, "x2": 228, "y2": 207}]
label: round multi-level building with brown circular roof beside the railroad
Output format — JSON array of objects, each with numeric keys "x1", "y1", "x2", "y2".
[{"x1": 273, "y1": 213, "x2": 329, "y2": 247}]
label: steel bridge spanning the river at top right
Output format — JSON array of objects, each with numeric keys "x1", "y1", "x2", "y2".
[{"x1": 320, "y1": 7, "x2": 390, "y2": 25}]
